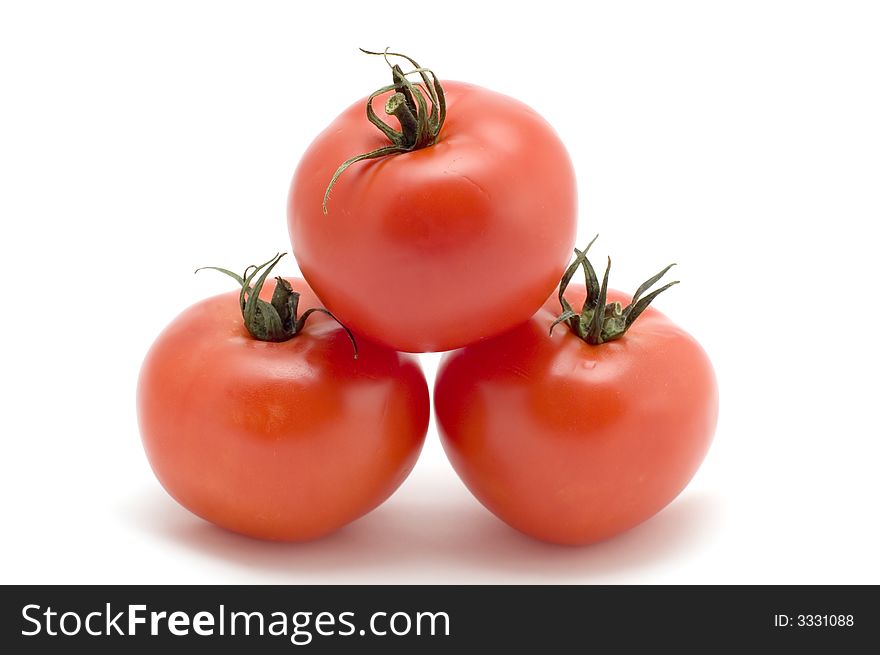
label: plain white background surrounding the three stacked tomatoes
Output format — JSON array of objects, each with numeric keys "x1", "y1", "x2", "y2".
[{"x1": 0, "y1": 0, "x2": 880, "y2": 583}]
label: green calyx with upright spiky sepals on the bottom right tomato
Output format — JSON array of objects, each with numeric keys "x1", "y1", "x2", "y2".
[{"x1": 550, "y1": 234, "x2": 678, "y2": 346}]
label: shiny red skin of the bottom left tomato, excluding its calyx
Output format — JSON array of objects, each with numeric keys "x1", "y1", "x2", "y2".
[{"x1": 137, "y1": 279, "x2": 430, "y2": 541}]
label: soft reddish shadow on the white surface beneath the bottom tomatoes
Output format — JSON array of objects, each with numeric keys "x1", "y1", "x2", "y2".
[{"x1": 125, "y1": 478, "x2": 720, "y2": 584}]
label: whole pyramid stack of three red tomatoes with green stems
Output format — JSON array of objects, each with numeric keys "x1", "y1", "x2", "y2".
[{"x1": 138, "y1": 52, "x2": 718, "y2": 544}]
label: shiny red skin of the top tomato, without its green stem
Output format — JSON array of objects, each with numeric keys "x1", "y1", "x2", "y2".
[{"x1": 288, "y1": 82, "x2": 577, "y2": 352}]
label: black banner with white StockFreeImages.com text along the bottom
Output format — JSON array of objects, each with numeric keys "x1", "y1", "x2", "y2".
[{"x1": 0, "y1": 586, "x2": 880, "y2": 654}]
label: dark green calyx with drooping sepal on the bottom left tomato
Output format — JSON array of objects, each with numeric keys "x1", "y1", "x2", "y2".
[{"x1": 196, "y1": 252, "x2": 358, "y2": 359}]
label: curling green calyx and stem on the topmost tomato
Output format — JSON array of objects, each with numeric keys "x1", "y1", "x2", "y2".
[{"x1": 323, "y1": 48, "x2": 446, "y2": 215}]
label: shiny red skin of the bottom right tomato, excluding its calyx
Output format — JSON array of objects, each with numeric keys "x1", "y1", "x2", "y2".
[{"x1": 434, "y1": 285, "x2": 718, "y2": 545}]
